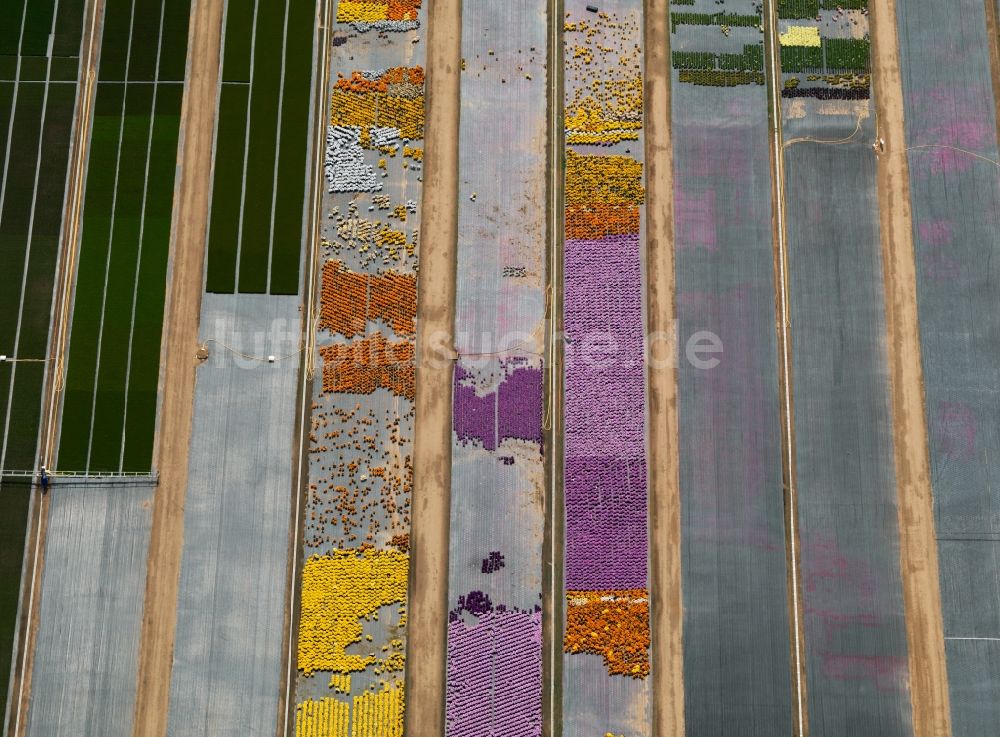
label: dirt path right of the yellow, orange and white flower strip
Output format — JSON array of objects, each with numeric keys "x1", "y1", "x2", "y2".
[{"x1": 406, "y1": 0, "x2": 462, "y2": 737}]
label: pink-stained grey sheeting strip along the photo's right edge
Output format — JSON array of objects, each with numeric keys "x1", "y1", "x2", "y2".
[{"x1": 896, "y1": 0, "x2": 1000, "y2": 737}]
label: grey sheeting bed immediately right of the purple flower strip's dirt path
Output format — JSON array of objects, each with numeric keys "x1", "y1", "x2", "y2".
[{"x1": 670, "y1": 0, "x2": 792, "y2": 737}]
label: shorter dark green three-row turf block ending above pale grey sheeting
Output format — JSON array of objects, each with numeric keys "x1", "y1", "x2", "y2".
[{"x1": 205, "y1": 0, "x2": 316, "y2": 294}]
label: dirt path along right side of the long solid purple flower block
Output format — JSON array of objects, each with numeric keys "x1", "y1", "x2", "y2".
[{"x1": 643, "y1": 0, "x2": 684, "y2": 737}]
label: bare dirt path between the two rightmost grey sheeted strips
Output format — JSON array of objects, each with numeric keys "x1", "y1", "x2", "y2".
[{"x1": 870, "y1": 0, "x2": 952, "y2": 737}]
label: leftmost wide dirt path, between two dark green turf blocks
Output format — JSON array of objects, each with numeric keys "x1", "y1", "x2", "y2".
[{"x1": 134, "y1": 0, "x2": 223, "y2": 737}]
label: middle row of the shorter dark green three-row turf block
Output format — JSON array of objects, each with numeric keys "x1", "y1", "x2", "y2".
[{"x1": 238, "y1": 2, "x2": 285, "y2": 294}]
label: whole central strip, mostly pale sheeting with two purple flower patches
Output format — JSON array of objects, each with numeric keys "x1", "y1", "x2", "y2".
[{"x1": 442, "y1": 0, "x2": 558, "y2": 737}]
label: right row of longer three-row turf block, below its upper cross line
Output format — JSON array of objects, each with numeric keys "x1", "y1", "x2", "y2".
[{"x1": 122, "y1": 86, "x2": 183, "y2": 471}]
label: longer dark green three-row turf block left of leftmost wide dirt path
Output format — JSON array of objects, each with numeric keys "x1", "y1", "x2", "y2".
[{"x1": 58, "y1": 0, "x2": 190, "y2": 472}]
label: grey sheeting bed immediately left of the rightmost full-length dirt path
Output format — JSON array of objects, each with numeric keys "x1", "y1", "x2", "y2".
[{"x1": 784, "y1": 109, "x2": 912, "y2": 737}]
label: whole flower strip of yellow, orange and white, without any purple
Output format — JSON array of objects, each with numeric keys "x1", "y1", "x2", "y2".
[{"x1": 295, "y1": 0, "x2": 424, "y2": 737}]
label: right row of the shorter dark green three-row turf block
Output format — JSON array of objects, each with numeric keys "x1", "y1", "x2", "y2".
[{"x1": 270, "y1": 0, "x2": 316, "y2": 294}]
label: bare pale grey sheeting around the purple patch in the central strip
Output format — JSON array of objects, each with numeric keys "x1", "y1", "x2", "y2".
[{"x1": 448, "y1": 0, "x2": 547, "y2": 620}]
